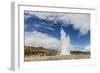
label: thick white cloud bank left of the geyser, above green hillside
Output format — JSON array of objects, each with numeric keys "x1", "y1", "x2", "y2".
[{"x1": 25, "y1": 31, "x2": 60, "y2": 49}]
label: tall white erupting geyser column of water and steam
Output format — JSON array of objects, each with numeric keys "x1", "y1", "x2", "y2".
[{"x1": 60, "y1": 28, "x2": 71, "y2": 55}]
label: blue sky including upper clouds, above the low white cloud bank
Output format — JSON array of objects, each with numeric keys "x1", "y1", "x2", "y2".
[{"x1": 24, "y1": 11, "x2": 90, "y2": 47}]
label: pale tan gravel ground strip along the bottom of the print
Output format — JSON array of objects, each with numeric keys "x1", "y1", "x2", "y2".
[{"x1": 24, "y1": 54, "x2": 90, "y2": 62}]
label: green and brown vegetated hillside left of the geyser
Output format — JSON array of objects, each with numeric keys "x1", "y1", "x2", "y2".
[{"x1": 24, "y1": 47, "x2": 58, "y2": 56}]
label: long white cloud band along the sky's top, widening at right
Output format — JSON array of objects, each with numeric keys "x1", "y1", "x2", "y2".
[{"x1": 24, "y1": 12, "x2": 90, "y2": 35}]
